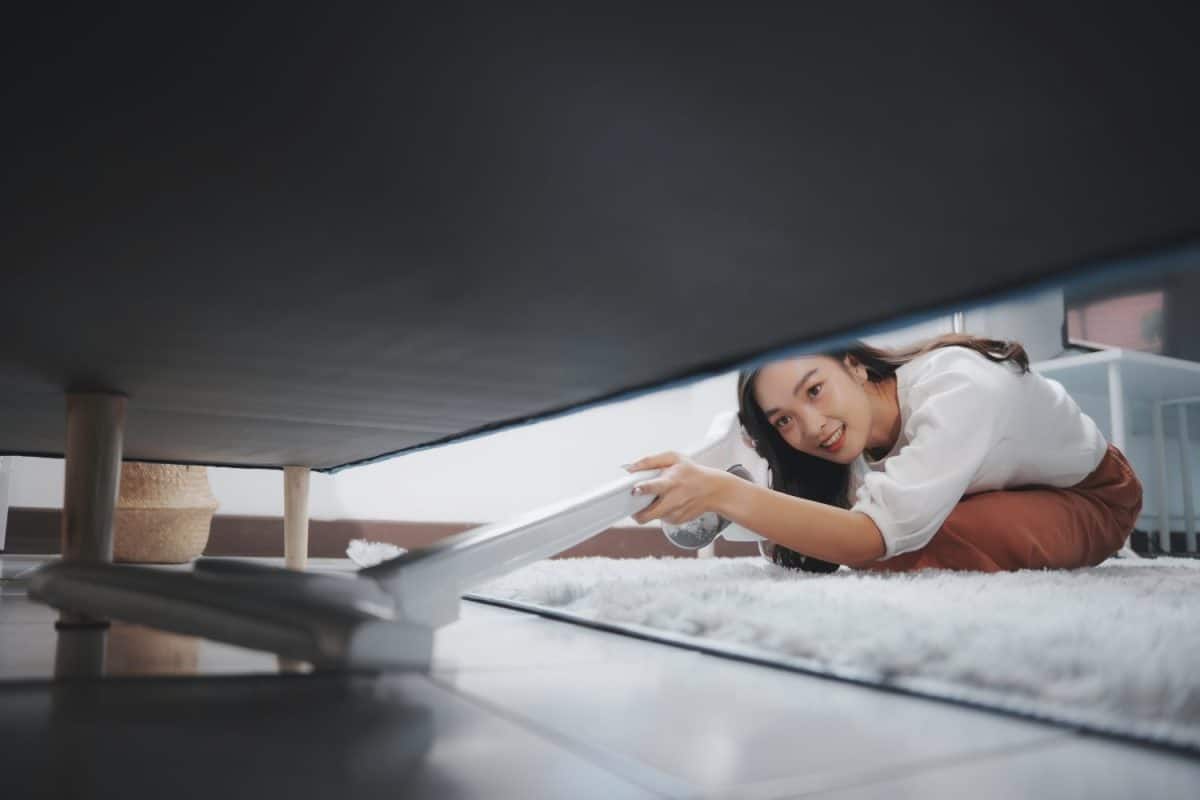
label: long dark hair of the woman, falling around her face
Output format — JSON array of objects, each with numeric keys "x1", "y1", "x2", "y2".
[{"x1": 738, "y1": 333, "x2": 1030, "y2": 572}]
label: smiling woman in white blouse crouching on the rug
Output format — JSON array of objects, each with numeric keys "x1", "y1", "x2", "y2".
[{"x1": 628, "y1": 335, "x2": 1141, "y2": 572}]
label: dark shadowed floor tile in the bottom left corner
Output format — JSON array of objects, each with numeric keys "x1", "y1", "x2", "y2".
[{"x1": 0, "y1": 674, "x2": 655, "y2": 800}]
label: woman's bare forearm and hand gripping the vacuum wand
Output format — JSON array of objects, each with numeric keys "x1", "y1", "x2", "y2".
[{"x1": 628, "y1": 453, "x2": 886, "y2": 566}]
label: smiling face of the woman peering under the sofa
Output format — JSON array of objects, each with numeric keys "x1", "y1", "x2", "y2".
[{"x1": 754, "y1": 355, "x2": 871, "y2": 464}]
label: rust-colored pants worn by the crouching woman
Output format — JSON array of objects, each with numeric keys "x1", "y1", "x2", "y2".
[{"x1": 862, "y1": 445, "x2": 1141, "y2": 572}]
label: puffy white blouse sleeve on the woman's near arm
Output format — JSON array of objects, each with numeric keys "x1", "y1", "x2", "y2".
[{"x1": 851, "y1": 369, "x2": 1003, "y2": 560}]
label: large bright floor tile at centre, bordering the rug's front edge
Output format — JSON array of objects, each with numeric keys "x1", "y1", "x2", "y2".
[{"x1": 436, "y1": 647, "x2": 1069, "y2": 796}]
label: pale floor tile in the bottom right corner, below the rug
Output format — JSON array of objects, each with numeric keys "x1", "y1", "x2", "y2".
[{"x1": 796, "y1": 736, "x2": 1200, "y2": 800}]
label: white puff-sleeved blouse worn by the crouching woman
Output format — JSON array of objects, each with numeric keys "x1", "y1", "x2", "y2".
[{"x1": 847, "y1": 347, "x2": 1108, "y2": 560}]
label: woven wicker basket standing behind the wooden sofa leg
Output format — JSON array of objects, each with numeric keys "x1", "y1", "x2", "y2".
[{"x1": 113, "y1": 462, "x2": 217, "y2": 564}]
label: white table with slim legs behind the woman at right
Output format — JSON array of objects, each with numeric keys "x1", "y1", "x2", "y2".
[{"x1": 1033, "y1": 348, "x2": 1200, "y2": 553}]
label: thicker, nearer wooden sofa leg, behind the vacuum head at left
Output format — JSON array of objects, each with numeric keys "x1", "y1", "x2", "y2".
[{"x1": 59, "y1": 393, "x2": 126, "y2": 626}]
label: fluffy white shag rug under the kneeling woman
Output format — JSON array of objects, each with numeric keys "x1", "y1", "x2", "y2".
[{"x1": 473, "y1": 558, "x2": 1200, "y2": 751}]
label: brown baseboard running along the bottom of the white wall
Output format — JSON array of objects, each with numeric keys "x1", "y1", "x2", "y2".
[{"x1": 2, "y1": 509, "x2": 758, "y2": 558}]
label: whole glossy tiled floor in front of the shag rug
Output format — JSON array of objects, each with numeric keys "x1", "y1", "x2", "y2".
[{"x1": 0, "y1": 557, "x2": 1200, "y2": 800}]
